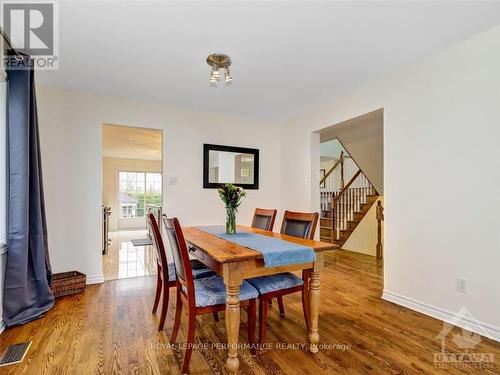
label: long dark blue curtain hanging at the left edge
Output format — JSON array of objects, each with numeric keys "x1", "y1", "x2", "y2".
[{"x1": 3, "y1": 56, "x2": 54, "y2": 327}]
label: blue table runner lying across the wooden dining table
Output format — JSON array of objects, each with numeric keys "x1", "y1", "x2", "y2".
[{"x1": 196, "y1": 225, "x2": 316, "y2": 268}]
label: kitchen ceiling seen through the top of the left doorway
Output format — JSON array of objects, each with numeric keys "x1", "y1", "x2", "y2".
[{"x1": 102, "y1": 124, "x2": 162, "y2": 160}]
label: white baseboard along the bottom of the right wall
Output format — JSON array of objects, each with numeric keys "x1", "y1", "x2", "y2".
[{"x1": 382, "y1": 290, "x2": 500, "y2": 342}]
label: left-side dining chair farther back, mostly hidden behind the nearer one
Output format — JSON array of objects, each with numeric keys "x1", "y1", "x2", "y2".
[{"x1": 146, "y1": 213, "x2": 215, "y2": 331}]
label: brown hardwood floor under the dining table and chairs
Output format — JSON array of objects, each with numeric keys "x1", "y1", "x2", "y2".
[{"x1": 0, "y1": 251, "x2": 500, "y2": 375}]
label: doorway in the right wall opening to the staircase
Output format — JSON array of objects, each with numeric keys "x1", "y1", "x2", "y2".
[{"x1": 317, "y1": 109, "x2": 384, "y2": 265}]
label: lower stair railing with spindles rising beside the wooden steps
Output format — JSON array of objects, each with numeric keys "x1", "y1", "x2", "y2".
[{"x1": 332, "y1": 169, "x2": 378, "y2": 240}]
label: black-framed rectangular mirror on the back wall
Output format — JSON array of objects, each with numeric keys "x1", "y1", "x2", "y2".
[{"x1": 203, "y1": 144, "x2": 259, "y2": 190}]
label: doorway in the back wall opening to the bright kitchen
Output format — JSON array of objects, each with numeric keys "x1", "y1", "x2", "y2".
[{"x1": 102, "y1": 124, "x2": 163, "y2": 280}]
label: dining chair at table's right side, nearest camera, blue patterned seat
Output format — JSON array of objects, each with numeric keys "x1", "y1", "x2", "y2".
[{"x1": 247, "y1": 211, "x2": 319, "y2": 344}]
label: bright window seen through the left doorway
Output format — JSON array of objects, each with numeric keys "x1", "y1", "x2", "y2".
[{"x1": 118, "y1": 172, "x2": 161, "y2": 218}]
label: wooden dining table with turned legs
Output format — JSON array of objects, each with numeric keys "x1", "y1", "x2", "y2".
[{"x1": 183, "y1": 225, "x2": 338, "y2": 374}]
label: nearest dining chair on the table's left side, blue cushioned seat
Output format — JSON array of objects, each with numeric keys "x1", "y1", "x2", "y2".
[{"x1": 163, "y1": 217, "x2": 259, "y2": 374}]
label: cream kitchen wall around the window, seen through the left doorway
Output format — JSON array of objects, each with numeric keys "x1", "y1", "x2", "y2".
[{"x1": 102, "y1": 157, "x2": 162, "y2": 231}]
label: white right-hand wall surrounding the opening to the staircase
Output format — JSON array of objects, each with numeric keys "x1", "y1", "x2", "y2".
[{"x1": 281, "y1": 26, "x2": 500, "y2": 340}]
